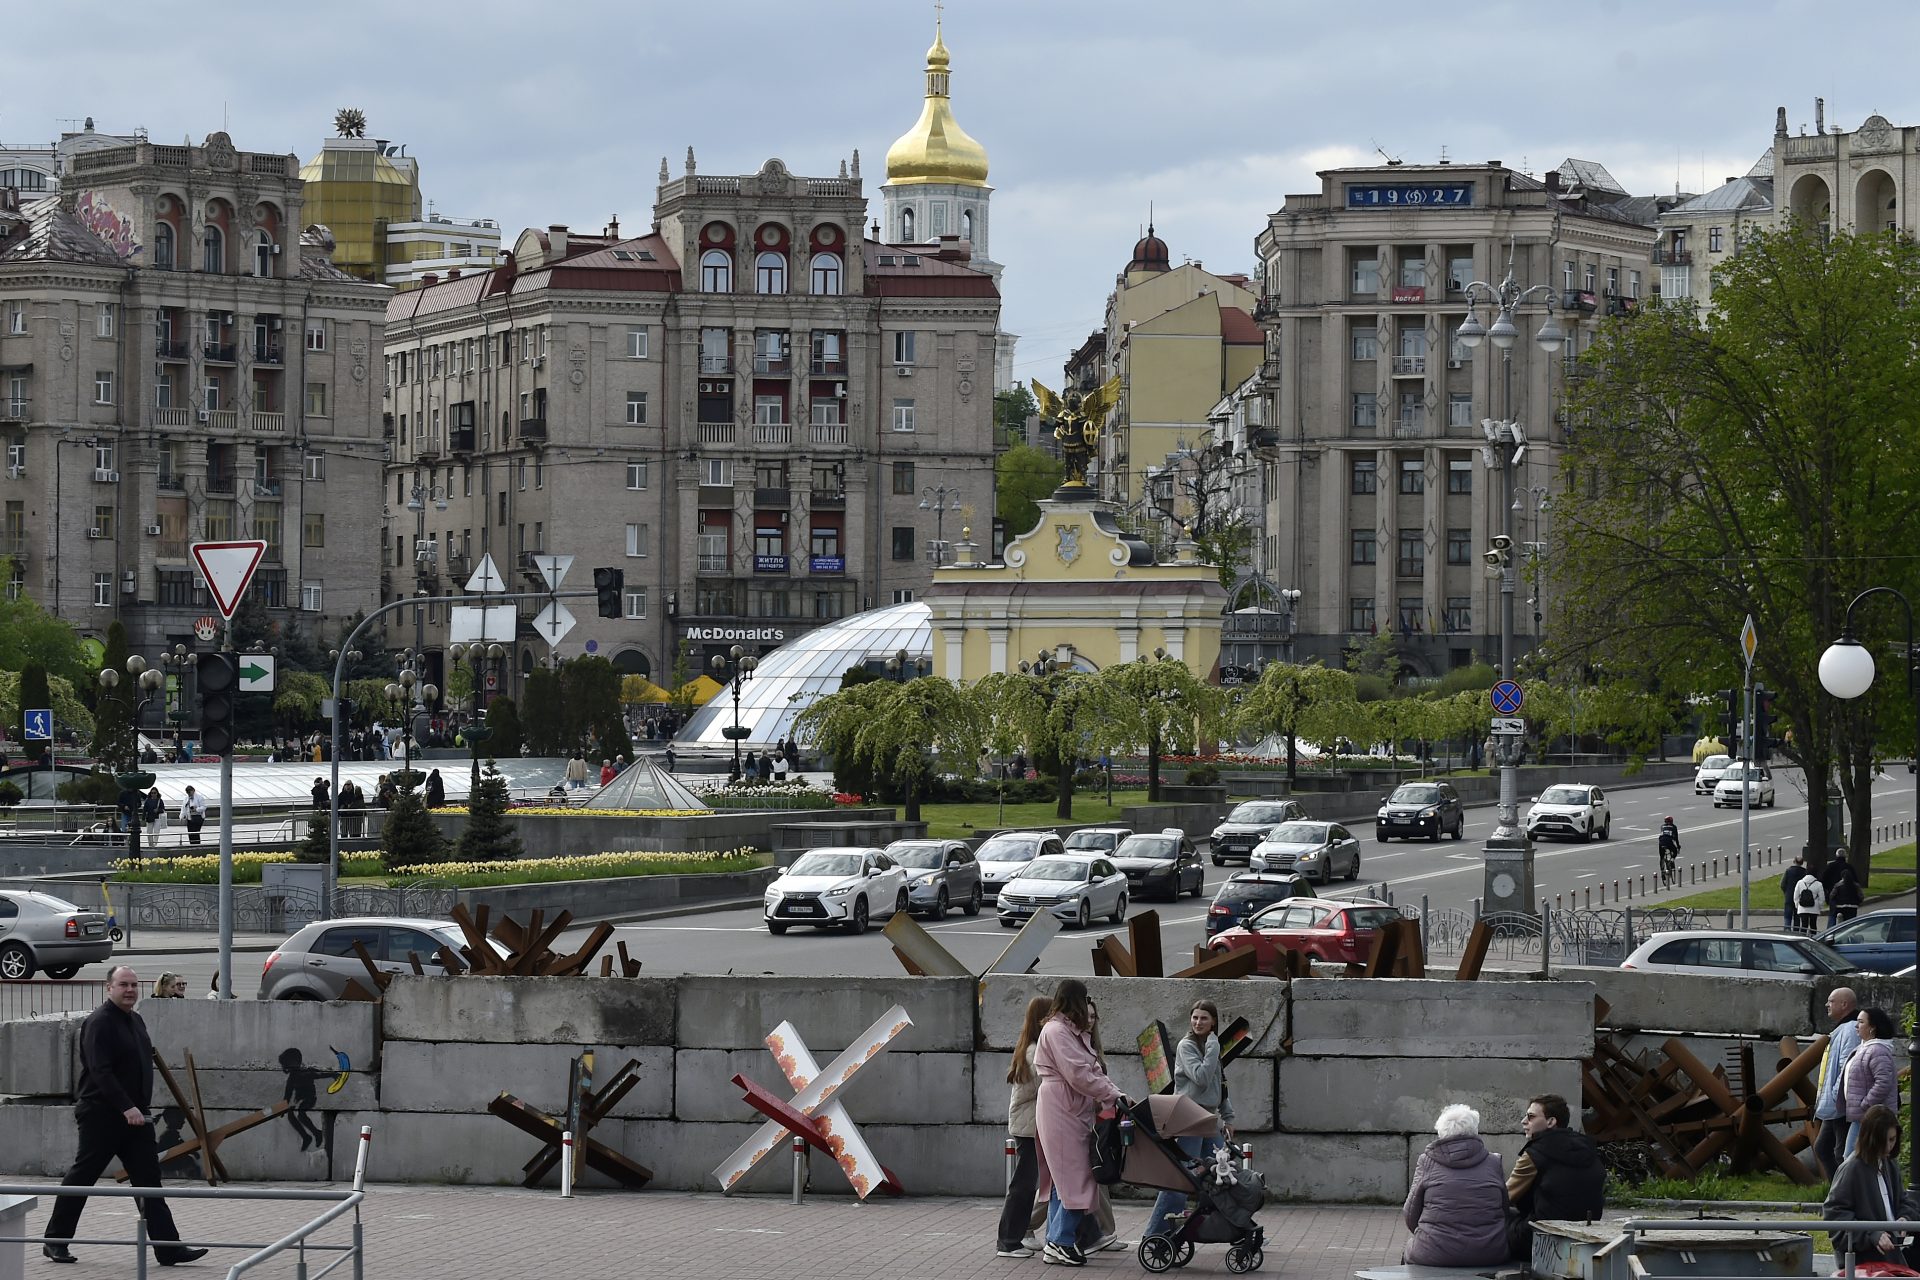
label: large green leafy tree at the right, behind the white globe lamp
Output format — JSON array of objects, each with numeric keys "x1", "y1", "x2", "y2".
[{"x1": 1553, "y1": 225, "x2": 1920, "y2": 879}]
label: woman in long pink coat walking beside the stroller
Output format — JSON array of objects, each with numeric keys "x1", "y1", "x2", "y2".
[{"x1": 1033, "y1": 979, "x2": 1121, "y2": 1267}]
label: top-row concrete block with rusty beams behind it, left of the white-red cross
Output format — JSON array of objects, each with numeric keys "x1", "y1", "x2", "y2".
[{"x1": 384, "y1": 975, "x2": 678, "y2": 1046}]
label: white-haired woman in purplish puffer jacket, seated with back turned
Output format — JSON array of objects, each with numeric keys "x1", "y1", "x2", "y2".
[{"x1": 1404, "y1": 1102, "x2": 1507, "y2": 1267}]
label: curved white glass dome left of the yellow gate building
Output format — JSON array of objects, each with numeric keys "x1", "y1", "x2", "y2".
[{"x1": 676, "y1": 601, "x2": 933, "y2": 750}]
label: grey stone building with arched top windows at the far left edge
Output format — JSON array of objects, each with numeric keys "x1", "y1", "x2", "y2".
[{"x1": 0, "y1": 132, "x2": 390, "y2": 656}]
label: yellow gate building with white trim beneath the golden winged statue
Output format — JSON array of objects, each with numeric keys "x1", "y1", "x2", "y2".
[{"x1": 922, "y1": 499, "x2": 1227, "y2": 683}]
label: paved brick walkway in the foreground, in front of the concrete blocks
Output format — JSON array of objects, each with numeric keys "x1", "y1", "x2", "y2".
[{"x1": 0, "y1": 1184, "x2": 1407, "y2": 1280}]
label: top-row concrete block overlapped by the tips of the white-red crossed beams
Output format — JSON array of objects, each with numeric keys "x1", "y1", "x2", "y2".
[{"x1": 675, "y1": 975, "x2": 973, "y2": 1067}]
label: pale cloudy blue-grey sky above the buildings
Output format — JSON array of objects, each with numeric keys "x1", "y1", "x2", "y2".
[{"x1": 0, "y1": 0, "x2": 1920, "y2": 380}]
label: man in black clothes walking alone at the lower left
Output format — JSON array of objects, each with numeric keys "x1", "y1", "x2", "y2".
[{"x1": 42, "y1": 965, "x2": 205, "y2": 1267}]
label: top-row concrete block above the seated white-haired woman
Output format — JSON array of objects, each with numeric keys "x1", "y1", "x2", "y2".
[{"x1": 1297, "y1": 979, "x2": 1594, "y2": 1059}]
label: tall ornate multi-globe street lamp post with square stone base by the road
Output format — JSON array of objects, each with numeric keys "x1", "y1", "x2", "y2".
[{"x1": 1455, "y1": 246, "x2": 1567, "y2": 913}]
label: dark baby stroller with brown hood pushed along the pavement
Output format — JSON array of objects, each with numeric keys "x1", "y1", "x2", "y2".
[{"x1": 1119, "y1": 1094, "x2": 1267, "y2": 1274}]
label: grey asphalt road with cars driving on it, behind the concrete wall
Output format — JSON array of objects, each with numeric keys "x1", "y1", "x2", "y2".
[{"x1": 105, "y1": 770, "x2": 1914, "y2": 996}]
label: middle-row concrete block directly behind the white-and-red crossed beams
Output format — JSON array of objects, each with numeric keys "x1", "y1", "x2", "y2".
[{"x1": 674, "y1": 1050, "x2": 973, "y2": 1125}]
